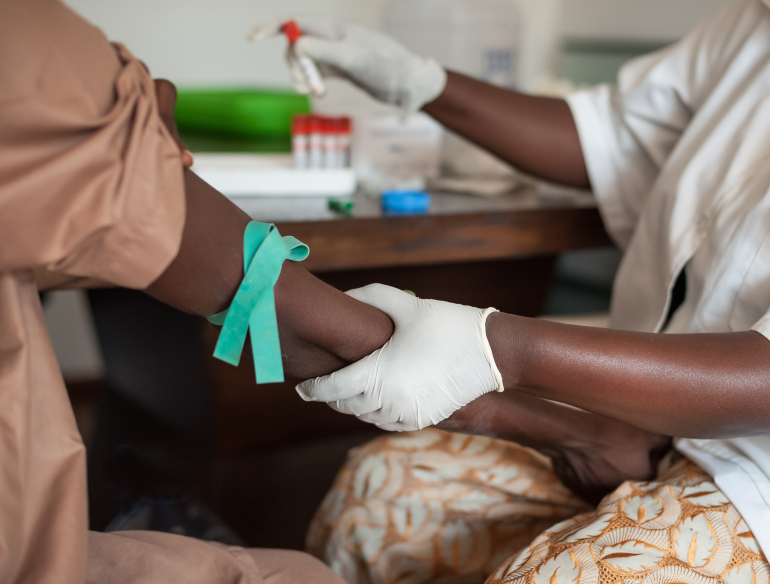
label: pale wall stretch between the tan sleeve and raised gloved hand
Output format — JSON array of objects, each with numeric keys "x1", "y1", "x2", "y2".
[{"x1": 65, "y1": 0, "x2": 385, "y2": 87}]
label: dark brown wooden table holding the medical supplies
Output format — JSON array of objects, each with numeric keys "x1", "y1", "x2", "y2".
[{"x1": 233, "y1": 185, "x2": 610, "y2": 273}]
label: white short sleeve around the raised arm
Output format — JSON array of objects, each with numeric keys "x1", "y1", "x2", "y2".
[{"x1": 567, "y1": 0, "x2": 767, "y2": 248}]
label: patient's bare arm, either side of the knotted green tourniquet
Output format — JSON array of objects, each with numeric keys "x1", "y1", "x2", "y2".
[{"x1": 147, "y1": 170, "x2": 393, "y2": 378}]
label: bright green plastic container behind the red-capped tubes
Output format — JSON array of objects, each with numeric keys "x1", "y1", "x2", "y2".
[{"x1": 176, "y1": 89, "x2": 310, "y2": 152}]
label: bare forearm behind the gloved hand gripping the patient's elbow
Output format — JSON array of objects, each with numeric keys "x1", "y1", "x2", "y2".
[{"x1": 487, "y1": 314, "x2": 770, "y2": 438}]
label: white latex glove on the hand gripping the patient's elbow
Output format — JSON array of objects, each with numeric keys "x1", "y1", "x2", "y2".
[{"x1": 297, "y1": 284, "x2": 503, "y2": 431}]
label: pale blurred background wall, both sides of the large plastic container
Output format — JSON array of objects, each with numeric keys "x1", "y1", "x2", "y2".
[{"x1": 65, "y1": 0, "x2": 727, "y2": 87}]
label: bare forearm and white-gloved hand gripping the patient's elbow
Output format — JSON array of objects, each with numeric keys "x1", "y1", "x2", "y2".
[{"x1": 300, "y1": 287, "x2": 770, "y2": 438}]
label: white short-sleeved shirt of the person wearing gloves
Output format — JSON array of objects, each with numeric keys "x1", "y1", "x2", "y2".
[{"x1": 569, "y1": 0, "x2": 770, "y2": 553}]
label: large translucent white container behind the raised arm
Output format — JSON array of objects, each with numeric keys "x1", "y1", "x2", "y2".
[{"x1": 384, "y1": 0, "x2": 562, "y2": 176}]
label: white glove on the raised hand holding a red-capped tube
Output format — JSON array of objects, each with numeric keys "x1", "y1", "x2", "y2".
[{"x1": 250, "y1": 18, "x2": 447, "y2": 111}]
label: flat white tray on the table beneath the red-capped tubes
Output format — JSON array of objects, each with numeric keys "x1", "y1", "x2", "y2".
[{"x1": 192, "y1": 154, "x2": 356, "y2": 197}]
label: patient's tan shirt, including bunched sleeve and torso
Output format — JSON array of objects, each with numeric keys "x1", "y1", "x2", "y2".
[{"x1": 0, "y1": 0, "x2": 185, "y2": 584}]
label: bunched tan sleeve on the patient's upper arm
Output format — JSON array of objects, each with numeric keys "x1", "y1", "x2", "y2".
[{"x1": 0, "y1": 0, "x2": 185, "y2": 288}]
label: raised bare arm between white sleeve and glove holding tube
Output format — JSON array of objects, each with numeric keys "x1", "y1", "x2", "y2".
[{"x1": 423, "y1": 71, "x2": 589, "y2": 187}]
